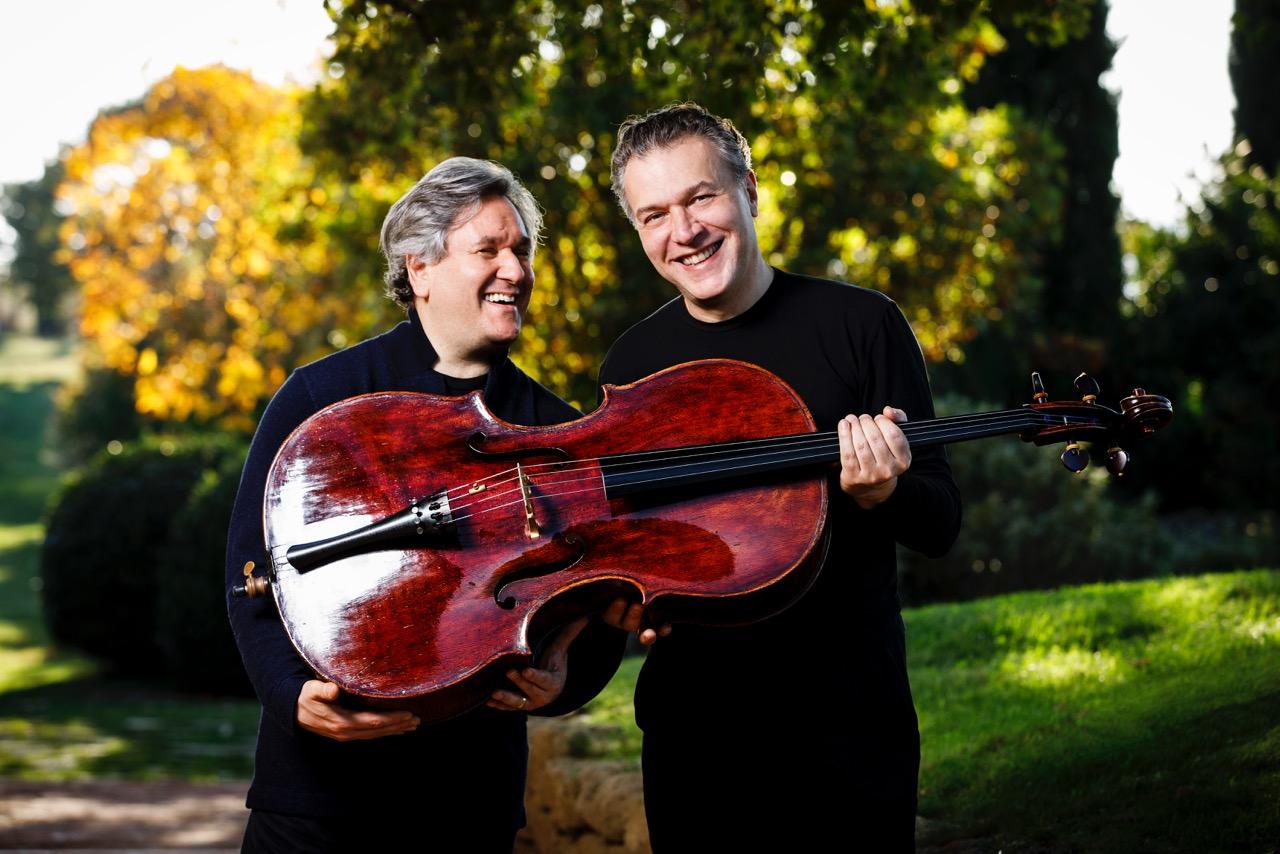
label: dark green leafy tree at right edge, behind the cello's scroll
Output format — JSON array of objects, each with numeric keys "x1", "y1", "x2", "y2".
[{"x1": 1126, "y1": 149, "x2": 1280, "y2": 511}]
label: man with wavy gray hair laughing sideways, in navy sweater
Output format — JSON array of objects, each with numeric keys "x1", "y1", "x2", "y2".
[{"x1": 227, "y1": 157, "x2": 623, "y2": 854}]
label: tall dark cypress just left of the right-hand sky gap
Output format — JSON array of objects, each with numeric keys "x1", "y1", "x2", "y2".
[{"x1": 946, "y1": 0, "x2": 1123, "y2": 404}]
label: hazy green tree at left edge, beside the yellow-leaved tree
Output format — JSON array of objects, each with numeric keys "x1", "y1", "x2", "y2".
[{"x1": 0, "y1": 160, "x2": 76, "y2": 335}]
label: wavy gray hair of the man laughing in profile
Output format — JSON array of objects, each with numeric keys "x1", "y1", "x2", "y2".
[{"x1": 379, "y1": 157, "x2": 543, "y2": 309}]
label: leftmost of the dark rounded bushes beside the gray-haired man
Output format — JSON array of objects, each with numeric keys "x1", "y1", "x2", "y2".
[{"x1": 41, "y1": 437, "x2": 241, "y2": 675}]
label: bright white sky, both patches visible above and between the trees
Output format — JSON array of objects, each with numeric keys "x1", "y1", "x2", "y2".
[{"x1": 0, "y1": 0, "x2": 1234, "y2": 234}]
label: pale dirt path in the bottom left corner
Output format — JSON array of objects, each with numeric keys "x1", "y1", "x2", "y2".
[{"x1": 0, "y1": 781, "x2": 248, "y2": 853}]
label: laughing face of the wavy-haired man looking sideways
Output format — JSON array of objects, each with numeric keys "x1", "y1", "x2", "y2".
[{"x1": 406, "y1": 197, "x2": 534, "y2": 373}]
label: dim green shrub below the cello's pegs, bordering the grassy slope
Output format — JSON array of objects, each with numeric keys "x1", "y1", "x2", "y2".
[{"x1": 900, "y1": 398, "x2": 1172, "y2": 603}]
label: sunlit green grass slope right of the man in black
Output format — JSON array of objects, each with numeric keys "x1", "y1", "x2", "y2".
[{"x1": 908, "y1": 571, "x2": 1280, "y2": 851}]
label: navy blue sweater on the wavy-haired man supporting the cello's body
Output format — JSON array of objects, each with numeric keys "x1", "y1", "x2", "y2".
[{"x1": 227, "y1": 311, "x2": 622, "y2": 827}]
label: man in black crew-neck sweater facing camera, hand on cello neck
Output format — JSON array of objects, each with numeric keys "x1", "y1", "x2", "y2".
[{"x1": 600, "y1": 104, "x2": 960, "y2": 853}]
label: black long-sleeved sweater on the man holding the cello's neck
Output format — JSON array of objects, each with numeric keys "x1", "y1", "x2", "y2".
[{"x1": 600, "y1": 270, "x2": 960, "y2": 732}]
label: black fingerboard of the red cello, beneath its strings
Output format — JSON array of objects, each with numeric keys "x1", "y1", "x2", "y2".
[{"x1": 600, "y1": 408, "x2": 1052, "y2": 497}]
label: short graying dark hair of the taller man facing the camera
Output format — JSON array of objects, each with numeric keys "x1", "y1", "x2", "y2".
[{"x1": 609, "y1": 101, "x2": 751, "y2": 219}]
